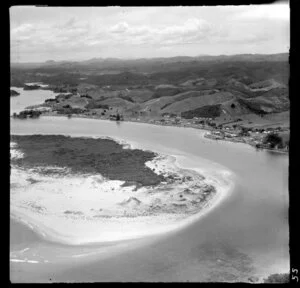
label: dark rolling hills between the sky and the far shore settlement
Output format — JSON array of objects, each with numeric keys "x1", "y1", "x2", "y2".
[{"x1": 11, "y1": 54, "x2": 289, "y2": 125}]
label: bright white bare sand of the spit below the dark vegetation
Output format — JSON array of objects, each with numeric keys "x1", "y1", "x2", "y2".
[{"x1": 11, "y1": 137, "x2": 233, "y2": 245}]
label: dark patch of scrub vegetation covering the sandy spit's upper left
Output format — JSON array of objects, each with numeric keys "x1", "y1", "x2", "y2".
[{"x1": 11, "y1": 135, "x2": 165, "y2": 186}]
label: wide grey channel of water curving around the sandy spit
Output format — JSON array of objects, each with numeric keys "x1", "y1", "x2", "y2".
[{"x1": 11, "y1": 117, "x2": 289, "y2": 281}]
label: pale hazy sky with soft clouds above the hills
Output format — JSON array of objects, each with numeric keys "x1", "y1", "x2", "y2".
[{"x1": 10, "y1": 2, "x2": 290, "y2": 62}]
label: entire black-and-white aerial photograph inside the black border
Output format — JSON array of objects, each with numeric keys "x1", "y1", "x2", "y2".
[{"x1": 9, "y1": 1, "x2": 292, "y2": 283}]
